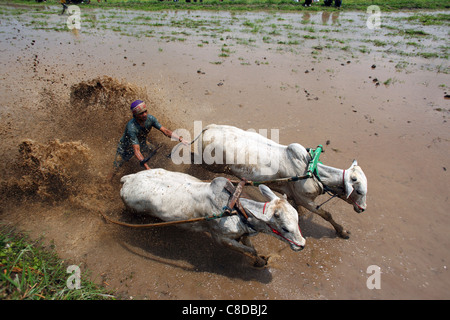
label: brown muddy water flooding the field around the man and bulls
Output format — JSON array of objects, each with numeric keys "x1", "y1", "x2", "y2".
[{"x1": 0, "y1": 6, "x2": 450, "y2": 299}]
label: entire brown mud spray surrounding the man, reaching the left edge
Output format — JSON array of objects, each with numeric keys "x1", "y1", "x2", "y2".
[{"x1": 1, "y1": 76, "x2": 193, "y2": 219}]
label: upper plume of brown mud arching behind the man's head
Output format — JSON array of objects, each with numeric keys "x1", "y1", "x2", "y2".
[{"x1": 66, "y1": 76, "x2": 181, "y2": 170}]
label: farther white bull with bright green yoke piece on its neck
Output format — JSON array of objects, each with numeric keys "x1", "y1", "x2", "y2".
[{"x1": 198, "y1": 124, "x2": 367, "y2": 239}]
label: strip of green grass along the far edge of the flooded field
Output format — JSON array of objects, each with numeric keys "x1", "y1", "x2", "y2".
[{"x1": 0, "y1": 0, "x2": 450, "y2": 12}]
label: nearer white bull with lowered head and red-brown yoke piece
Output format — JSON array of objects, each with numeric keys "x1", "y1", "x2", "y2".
[{"x1": 120, "y1": 169, "x2": 305, "y2": 266}]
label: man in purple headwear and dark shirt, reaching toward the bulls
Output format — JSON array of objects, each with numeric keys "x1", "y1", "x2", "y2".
[{"x1": 109, "y1": 100, "x2": 189, "y2": 180}]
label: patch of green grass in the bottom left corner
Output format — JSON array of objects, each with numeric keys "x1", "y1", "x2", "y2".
[{"x1": 0, "y1": 226, "x2": 114, "y2": 300}]
